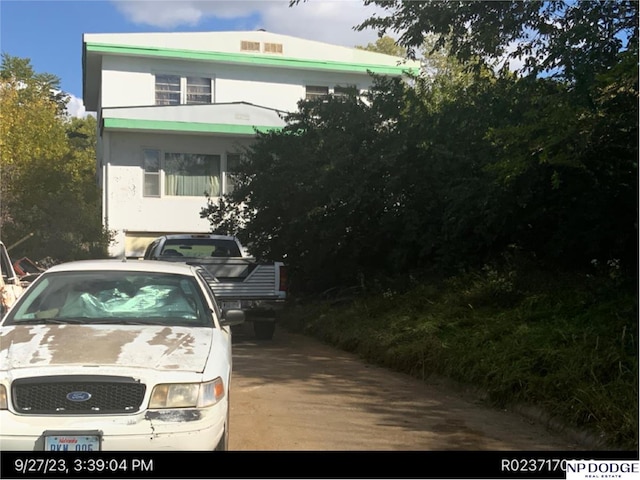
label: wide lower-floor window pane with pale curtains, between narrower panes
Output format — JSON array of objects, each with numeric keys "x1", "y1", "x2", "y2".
[{"x1": 164, "y1": 153, "x2": 220, "y2": 197}]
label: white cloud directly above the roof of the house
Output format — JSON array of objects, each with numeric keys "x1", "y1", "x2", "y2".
[{"x1": 111, "y1": 0, "x2": 379, "y2": 47}]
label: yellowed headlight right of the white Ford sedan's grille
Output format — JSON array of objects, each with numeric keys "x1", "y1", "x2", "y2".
[{"x1": 149, "y1": 377, "x2": 224, "y2": 408}]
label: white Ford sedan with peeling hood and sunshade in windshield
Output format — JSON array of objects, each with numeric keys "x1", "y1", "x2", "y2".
[{"x1": 0, "y1": 260, "x2": 244, "y2": 451}]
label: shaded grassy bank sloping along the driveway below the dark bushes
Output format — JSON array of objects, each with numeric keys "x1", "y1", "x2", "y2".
[{"x1": 281, "y1": 268, "x2": 638, "y2": 450}]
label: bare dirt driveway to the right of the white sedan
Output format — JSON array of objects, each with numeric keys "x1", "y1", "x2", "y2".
[{"x1": 229, "y1": 325, "x2": 584, "y2": 451}]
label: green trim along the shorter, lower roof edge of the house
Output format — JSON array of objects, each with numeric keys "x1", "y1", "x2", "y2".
[{"x1": 103, "y1": 118, "x2": 282, "y2": 135}]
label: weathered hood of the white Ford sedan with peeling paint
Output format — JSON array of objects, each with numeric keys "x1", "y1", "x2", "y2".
[{"x1": 0, "y1": 325, "x2": 213, "y2": 372}]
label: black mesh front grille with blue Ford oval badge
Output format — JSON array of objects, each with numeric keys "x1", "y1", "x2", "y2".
[{"x1": 12, "y1": 375, "x2": 146, "y2": 415}]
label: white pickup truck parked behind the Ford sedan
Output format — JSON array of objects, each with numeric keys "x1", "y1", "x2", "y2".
[{"x1": 144, "y1": 233, "x2": 287, "y2": 340}]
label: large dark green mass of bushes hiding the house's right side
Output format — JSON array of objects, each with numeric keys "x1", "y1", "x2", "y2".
[{"x1": 201, "y1": 39, "x2": 638, "y2": 292}]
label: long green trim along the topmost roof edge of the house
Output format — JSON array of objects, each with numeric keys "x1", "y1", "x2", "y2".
[{"x1": 85, "y1": 43, "x2": 420, "y2": 75}]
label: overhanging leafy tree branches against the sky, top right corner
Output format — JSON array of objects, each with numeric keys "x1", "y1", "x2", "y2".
[{"x1": 358, "y1": 0, "x2": 638, "y2": 84}]
